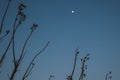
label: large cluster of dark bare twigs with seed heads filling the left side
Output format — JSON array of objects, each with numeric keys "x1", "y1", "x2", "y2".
[{"x1": 0, "y1": 0, "x2": 49, "y2": 80}]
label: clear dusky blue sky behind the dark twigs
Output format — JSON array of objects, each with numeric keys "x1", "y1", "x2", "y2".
[{"x1": 0, "y1": 0, "x2": 120, "y2": 80}]
